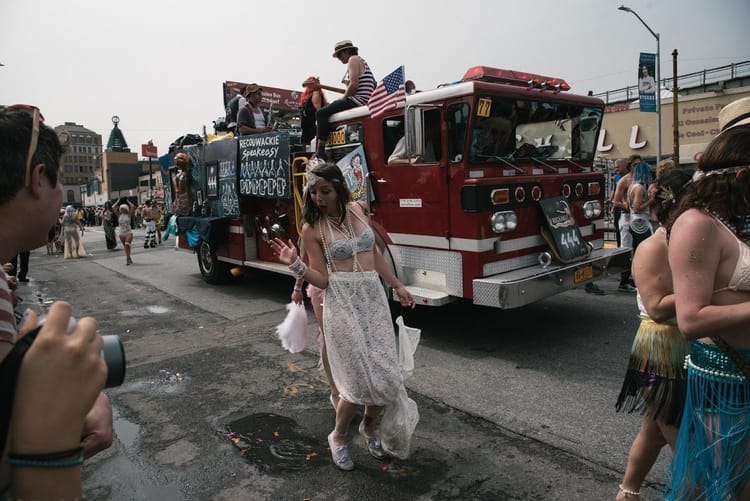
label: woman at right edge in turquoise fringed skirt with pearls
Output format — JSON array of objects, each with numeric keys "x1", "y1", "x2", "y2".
[{"x1": 667, "y1": 98, "x2": 750, "y2": 500}]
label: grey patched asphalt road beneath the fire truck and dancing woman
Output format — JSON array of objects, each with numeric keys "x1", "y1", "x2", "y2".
[{"x1": 11, "y1": 229, "x2": 670, "y2": 501}]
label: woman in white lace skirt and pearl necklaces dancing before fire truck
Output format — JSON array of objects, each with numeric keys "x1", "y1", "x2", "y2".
[{"x1": 270, "y1": 163, "x2": 419, "y2": 470}]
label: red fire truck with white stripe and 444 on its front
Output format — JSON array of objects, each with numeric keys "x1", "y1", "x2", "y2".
[{"x1": 178, "y1": 67, "x2": 627, "y2": 309}]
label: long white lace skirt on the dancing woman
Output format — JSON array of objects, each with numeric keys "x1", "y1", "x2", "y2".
[{"x1": 323, "y1": 271, "x2": 419, "y2": 459}]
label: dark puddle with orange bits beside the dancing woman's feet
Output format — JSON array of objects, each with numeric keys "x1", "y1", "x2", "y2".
[{"x1": 227, "y1": 413, "x2": 330, "y2": 472}]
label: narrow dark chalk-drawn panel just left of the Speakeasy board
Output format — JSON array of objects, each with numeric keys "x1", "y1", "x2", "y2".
[{"x1": 205, "y1": 139, "x2": 240, "y2": 216}]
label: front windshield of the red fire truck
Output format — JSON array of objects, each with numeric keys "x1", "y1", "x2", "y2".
[{"x1": 469, "y1": 95, "x2": 602, "y2": 164}]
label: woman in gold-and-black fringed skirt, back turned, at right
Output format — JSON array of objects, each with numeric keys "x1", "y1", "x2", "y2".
[{"x1": 615, "y1": 169, "x2": 692, "y2": 501}]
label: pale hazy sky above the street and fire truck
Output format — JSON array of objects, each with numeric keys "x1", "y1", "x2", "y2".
[{"x1": 0, "y1": 0, "x2": 750, "y2": 154}]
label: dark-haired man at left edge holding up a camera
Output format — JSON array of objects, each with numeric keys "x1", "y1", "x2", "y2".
[{"x1": 0, "y1": 105, "x2": 112, "y2": 499}]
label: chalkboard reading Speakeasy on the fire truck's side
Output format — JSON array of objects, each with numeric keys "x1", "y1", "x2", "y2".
[{"x1": 238, "y1": 131, "x2": 292, "y2": 198}]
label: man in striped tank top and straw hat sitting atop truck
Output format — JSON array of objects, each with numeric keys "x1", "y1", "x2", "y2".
[{"x1": 315, "y1": 40, "x2": 377, "y2": 160}]
